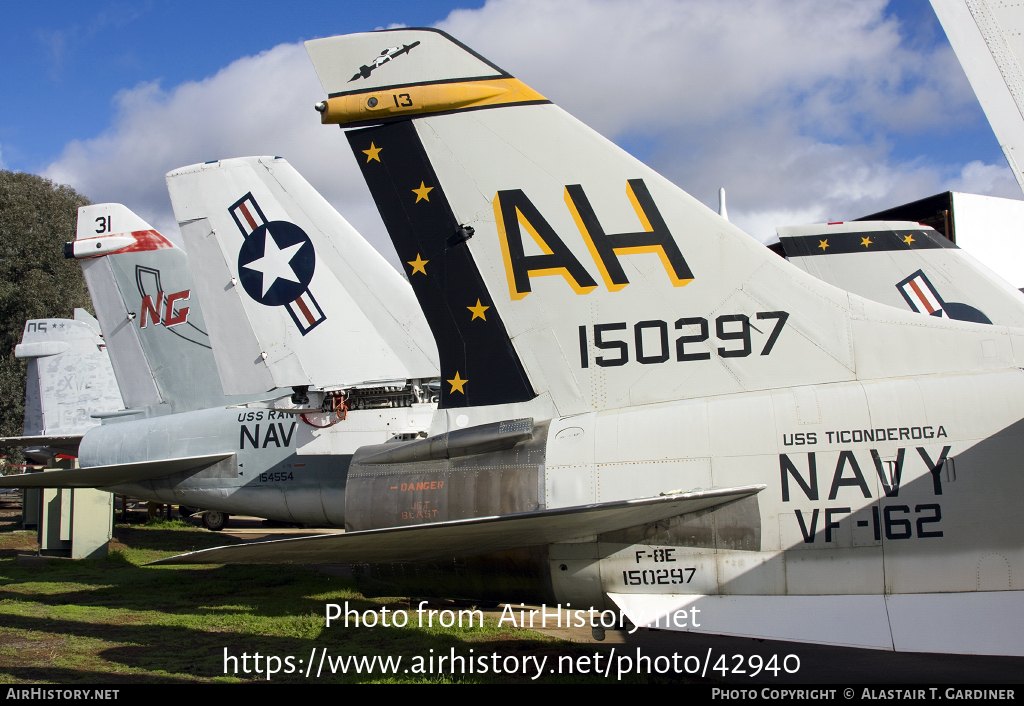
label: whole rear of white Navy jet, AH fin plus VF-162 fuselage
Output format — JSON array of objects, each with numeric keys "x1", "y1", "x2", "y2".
[{"x1": 159, "y1": 30, "x2": 1024, "y2": 655}]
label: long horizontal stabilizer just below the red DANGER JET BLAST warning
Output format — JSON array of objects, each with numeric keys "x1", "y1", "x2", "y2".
[{"x1": 154, "y1": 486, "x2": 765, "y2": 564}]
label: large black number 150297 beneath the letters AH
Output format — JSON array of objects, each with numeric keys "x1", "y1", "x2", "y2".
[{"x1": 580, "y1": 312, "x2": 790, "y2": 368}]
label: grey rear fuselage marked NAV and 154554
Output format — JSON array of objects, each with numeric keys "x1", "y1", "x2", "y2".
[{"x1": 79, "y1": 406, "x2": 429, "y2": 527}]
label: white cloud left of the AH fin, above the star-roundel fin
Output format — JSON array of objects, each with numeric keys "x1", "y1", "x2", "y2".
[{"x1": 44, "y1": 44, "x2": 397, "y2": 262}]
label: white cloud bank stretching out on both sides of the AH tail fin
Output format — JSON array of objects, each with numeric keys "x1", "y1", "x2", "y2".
[{"x1": 45, "y1": 0, "x2": 1020, "y2": 255}]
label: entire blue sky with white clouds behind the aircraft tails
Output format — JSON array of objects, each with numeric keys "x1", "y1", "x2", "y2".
[{"x1": 0, "y1": 0, "x2": 1021, "y2": 251}]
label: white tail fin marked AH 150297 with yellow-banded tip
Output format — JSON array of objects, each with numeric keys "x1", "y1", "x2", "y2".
[{"x1": 306, "y1": 30, "x2": 1013, "y2": 423}]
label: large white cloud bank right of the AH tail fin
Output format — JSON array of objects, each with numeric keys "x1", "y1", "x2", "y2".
[{"x1": 440, "y1": 0, "x2": 1020, "y2": 240}]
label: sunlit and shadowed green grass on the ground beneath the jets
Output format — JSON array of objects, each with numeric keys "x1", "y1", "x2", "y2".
[{"x1": 0, "y1": 495, "x2": 634, "y2": 683}]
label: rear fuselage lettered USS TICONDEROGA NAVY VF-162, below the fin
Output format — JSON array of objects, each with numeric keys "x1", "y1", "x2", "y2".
[{"x1": 346, "y1": 370, "x2": 1024, "y2": 654}]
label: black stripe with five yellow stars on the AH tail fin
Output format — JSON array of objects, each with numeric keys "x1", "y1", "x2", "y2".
[{"x1": 345, "y1": 120, "x2": 537, "y2": 409}]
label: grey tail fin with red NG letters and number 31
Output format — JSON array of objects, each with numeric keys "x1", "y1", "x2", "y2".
[{"x1": 65, "y1": 204, "x2": 232, "y2": 412}]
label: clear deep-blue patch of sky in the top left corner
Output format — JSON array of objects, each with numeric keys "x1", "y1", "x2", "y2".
[{"x1": 0, "y1": 0, "x2": 483, "y2": 171}]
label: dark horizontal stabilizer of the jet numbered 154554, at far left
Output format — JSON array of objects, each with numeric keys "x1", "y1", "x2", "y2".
[{"x1": 3, "y1": 454, "x2": 232, "y2": 488}]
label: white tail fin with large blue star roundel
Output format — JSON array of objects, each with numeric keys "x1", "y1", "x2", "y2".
[{"x1": 167, "y1": 157, "x2": 437, "y2": 392}]
